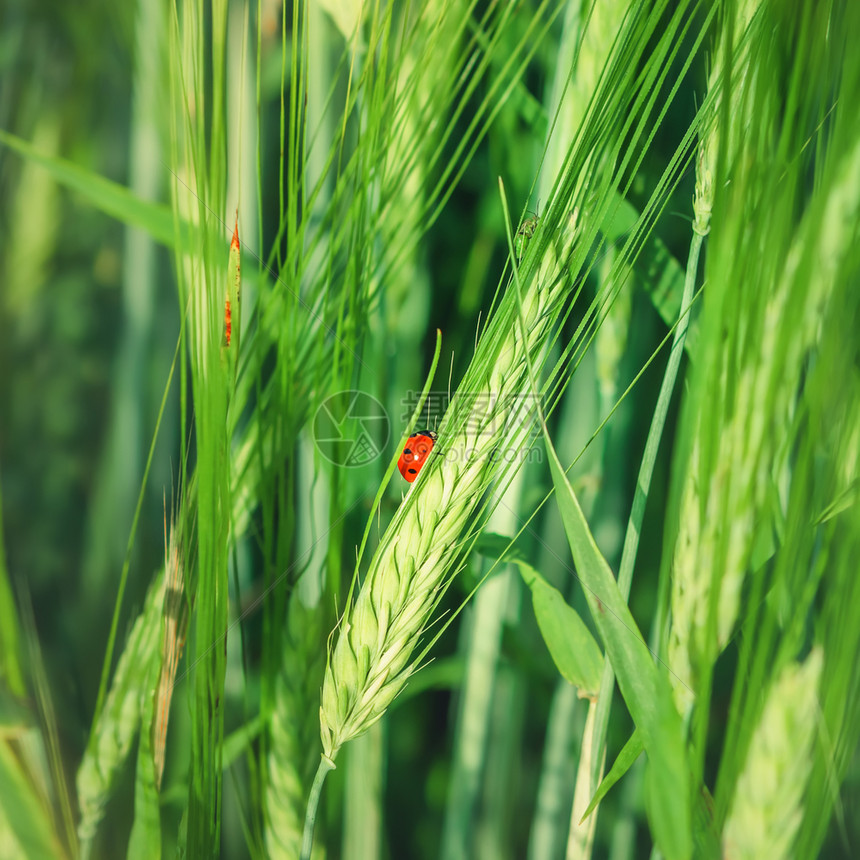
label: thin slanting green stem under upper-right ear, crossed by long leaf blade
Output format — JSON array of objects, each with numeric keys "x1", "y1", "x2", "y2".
[{"x1": 592, "y1": 232, "x2": 705, "y2": 800}]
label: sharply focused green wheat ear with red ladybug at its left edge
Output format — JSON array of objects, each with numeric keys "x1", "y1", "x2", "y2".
[{"x1": 320, "y1": 213, "x2": 575, "y2": 762}]
